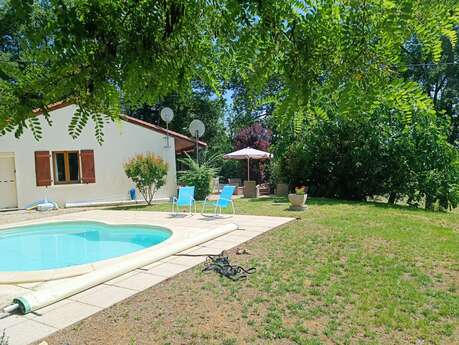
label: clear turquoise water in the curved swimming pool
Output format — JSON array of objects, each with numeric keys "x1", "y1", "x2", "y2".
[{"x1": 0, "y1": 222, "x2": 172, "y2": 272}]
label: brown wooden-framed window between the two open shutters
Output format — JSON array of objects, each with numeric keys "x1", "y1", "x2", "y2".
[{"x1": 53, "y1": 151, "x2": 80, "y2": 184}]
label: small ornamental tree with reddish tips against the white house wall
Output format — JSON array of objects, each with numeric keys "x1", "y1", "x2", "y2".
[{"x1": 124, "y1": 153, "x2": 167, "y2": 205}]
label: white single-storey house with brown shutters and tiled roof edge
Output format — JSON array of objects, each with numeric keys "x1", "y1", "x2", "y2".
[{"x1": 0, "y1": 103, "x2": 206, "y2": 209}]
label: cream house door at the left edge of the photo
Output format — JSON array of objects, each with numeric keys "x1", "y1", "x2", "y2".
[{"x1": 0, "y1": 154, "x2": 18, "y2": 209}]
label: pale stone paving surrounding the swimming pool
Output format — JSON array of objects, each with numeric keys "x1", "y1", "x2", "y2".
[{"x1": 0, "y1": 210, "x2": 294, "y2": 345}]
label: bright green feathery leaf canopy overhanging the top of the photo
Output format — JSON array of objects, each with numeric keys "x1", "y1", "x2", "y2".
[{"x1": 0, "y1": 0, "x2": 459, "y2": 141}]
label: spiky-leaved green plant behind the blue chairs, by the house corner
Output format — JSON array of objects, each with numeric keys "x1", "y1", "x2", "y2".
[{"x1": 179, "y1": 154, "x2": 221, "y2": 200}]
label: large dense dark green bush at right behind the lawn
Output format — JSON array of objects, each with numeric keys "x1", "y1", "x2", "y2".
[{"x1": 275, "y1": 107, "x2": 459, "y2": 209}]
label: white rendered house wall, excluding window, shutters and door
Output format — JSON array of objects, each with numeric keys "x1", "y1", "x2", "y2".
[{"x1": 0, "y1": 105, "x2": 176, "y2": 208}]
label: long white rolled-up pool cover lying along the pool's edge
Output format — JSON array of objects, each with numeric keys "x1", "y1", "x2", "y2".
[{"x1": 3, "y1": 224, "x2": 238, "y2": 314}]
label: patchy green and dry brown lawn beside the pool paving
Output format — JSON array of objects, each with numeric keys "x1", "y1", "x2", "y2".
[{"x1": 45, "y1": 199, "x2": 459, "y2": 345}]
